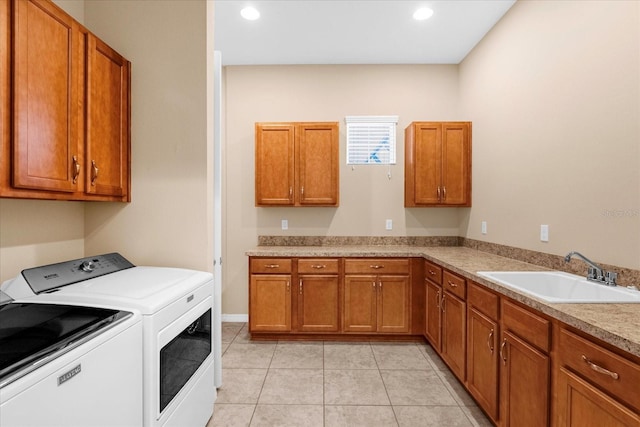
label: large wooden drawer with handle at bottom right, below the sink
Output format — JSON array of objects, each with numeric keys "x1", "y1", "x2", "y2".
[{"x1": 558, "y1": 329, "x2": 640, "y2": 409}]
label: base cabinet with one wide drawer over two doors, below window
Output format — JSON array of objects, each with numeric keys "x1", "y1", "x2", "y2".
[{"x1": 344, "y1": 259, "x2": 411, "y2": 334}]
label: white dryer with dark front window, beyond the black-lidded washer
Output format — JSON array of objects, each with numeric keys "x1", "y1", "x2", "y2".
[{"x1": 2, "y1": 253, "x2": 222, "y2": 427}]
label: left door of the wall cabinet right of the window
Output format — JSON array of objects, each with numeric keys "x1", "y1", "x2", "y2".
[{"x1": 405, "y1": 123, "x2": 442, "y2": 206}]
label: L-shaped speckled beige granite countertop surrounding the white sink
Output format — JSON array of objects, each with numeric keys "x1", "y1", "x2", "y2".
[{"x1": 246, "y1": 245, "x2": 640, "y2": 357}]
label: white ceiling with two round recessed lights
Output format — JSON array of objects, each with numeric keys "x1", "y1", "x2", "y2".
[{"x1": 214, "y1": 0, "x2": 515, "y2": 65}]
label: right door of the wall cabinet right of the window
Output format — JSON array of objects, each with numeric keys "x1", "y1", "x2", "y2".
[{"x1": 441, "y1": 122, "x2": 471, "y2": 206}]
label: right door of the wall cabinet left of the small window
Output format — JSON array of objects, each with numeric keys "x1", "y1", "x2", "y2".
[{"x1": 296, "y1": 123, "x2": 339, "y2": 206}]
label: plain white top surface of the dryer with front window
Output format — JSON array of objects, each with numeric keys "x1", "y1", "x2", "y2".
[{"x1": 2, "y1": 267, "x2": 213, "y2": 315}]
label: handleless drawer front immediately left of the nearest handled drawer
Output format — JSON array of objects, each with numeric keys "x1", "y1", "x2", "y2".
[{"x1": 502, "y1": 299, "x2": 551, "y2": 353}]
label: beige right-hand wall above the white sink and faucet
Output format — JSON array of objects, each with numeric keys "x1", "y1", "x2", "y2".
[{"x1": 460, "y1": 1, "x2": 640, "y2": 269}]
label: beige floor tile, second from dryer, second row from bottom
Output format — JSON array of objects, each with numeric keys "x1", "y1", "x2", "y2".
[{"x1": 258, "y1": 369, "x2": 324, "y2": 405}]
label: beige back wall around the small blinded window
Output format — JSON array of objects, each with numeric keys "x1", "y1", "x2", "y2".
[{"x1": 223, "y1": 65, "x2": 464, "y2": 313}]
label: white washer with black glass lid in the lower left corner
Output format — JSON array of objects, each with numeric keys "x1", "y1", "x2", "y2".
[{"x1": 0, "y1": 291, "x2": 143, "y2": 427}]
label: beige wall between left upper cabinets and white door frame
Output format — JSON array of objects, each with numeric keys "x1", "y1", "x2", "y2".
[{"x1": 85, "y1": 0, "x2": 213, "y2": 271}]
